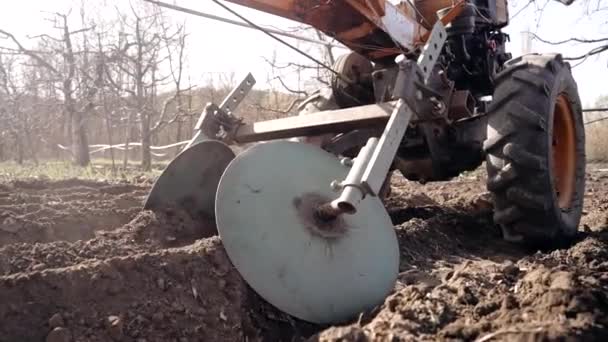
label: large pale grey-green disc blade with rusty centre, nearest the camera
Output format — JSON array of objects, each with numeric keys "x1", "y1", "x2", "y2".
[{"x1": 215, "y1": 141, "x2": 399, "y2": 323}]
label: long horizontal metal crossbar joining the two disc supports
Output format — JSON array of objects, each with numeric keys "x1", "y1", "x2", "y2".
[{"x1": 234, "y1": 101, "x2": 397, "y2": 143}]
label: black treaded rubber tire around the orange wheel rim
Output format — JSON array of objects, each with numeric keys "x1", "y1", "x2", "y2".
[{"x1": 484, "y1": 54, "x2": 586, "y2": 248}]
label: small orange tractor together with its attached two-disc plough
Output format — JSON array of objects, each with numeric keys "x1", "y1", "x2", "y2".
[{"x1": 144, "y1": 0, "x2": 585, "y2": 324}]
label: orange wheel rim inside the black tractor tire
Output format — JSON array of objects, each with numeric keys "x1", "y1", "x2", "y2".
[{"x1": 552, "y1": 94, "x2": 577, "y2": 209}]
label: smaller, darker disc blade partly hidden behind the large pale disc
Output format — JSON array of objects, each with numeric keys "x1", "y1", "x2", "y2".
[{"x1": 144, "y1": 140, "x2": 234, "y2": 235}]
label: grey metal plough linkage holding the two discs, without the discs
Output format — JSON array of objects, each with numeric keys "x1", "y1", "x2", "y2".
[{"x1": 188, "y1": 21, "x2": 447, "y2": 220}]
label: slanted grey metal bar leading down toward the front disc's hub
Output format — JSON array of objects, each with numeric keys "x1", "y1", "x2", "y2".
[{"x1": 361, "y1": 100, "x2": 414, "y2": 196}]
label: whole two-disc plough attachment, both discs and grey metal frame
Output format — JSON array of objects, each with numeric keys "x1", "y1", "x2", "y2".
[{"x1": 148, "y1": 21, "x2": 447, "y2": 323}]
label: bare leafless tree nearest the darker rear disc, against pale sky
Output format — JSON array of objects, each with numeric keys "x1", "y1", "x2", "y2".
[{"x1": 106, "y1": 6, "x2": 186, "y2": 170}]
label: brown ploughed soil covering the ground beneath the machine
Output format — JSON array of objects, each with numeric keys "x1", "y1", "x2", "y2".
[{"x1": 0, "y1": 165, "x2": 608, "y2": 342}]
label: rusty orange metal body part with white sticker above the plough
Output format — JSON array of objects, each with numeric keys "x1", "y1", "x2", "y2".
[{"x1": 226, "y1": 0, "x2": 426, "y2": 61}]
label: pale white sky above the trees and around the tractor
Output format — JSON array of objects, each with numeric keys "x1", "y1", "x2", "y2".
[{"x1": 0, "y1": 0, "x2": 608, "y2": 105}]
